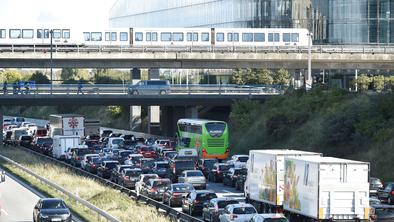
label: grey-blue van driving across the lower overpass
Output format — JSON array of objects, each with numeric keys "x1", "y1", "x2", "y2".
[{"x1": 129, "y1": 80, "x2": 170, "y2": 95}]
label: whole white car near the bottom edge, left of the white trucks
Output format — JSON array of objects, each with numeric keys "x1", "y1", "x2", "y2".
[{"x1": 219, "y1": 203, "x2": 257, "y2": 222}]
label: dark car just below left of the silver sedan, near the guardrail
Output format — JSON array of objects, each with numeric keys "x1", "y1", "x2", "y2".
[{"x1": 163, "y1": 183, "x2": 194, "y2": 207}]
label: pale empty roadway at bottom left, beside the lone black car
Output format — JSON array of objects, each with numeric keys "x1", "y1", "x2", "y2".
[{"x1": 0, "y1": 171, "x2": 40, "y2": 222}]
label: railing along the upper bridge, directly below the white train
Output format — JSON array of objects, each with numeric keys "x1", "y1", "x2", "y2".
[{"x1": 0, "y1": 44, "x2": 394, "y2": 54}]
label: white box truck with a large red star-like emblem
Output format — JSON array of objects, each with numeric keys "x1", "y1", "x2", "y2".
[{"x1": 49, "y1": 114, "x2": 85, "y2": 138}]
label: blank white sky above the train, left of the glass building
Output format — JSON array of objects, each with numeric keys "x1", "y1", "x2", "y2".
[{"x1": 0, "y1": 0, "x2": 116, "y2": 27}]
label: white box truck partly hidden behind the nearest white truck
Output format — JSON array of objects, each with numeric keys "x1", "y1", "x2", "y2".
[{"x1": 244, "y1": 149, "x2": 322, "y2": 213}]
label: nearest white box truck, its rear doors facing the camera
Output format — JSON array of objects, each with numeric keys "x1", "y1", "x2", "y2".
[{"x1": 283, "y1": 156, "x2": 370, "y2": 221}]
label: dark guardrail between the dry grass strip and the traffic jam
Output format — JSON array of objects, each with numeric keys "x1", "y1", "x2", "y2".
[{"x1": 10, "y1": 147, "x2": 203, "y2": 222}]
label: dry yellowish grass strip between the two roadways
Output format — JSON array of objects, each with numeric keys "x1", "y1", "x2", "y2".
[{"x1": 0, "y1": 147, "x2": 170, "y2": 222}]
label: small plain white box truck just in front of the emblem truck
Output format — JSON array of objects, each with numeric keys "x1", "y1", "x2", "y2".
[{"x1": 52, "y1": 135, "x2": 81, "y2": 159}]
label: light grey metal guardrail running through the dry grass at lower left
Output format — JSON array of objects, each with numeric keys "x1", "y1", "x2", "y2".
[{"x1": 0, "y1": 155, "x2": 120, "y2": 222}]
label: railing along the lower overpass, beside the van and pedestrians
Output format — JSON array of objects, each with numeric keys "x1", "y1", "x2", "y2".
[{"x1": 0, "y1": 84, "x2": 286, "y2": 96}]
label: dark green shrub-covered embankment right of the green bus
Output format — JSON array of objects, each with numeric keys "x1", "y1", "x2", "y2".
[{"x1": 230, "y1": 89, "x2": 394, "y2": 181}]
